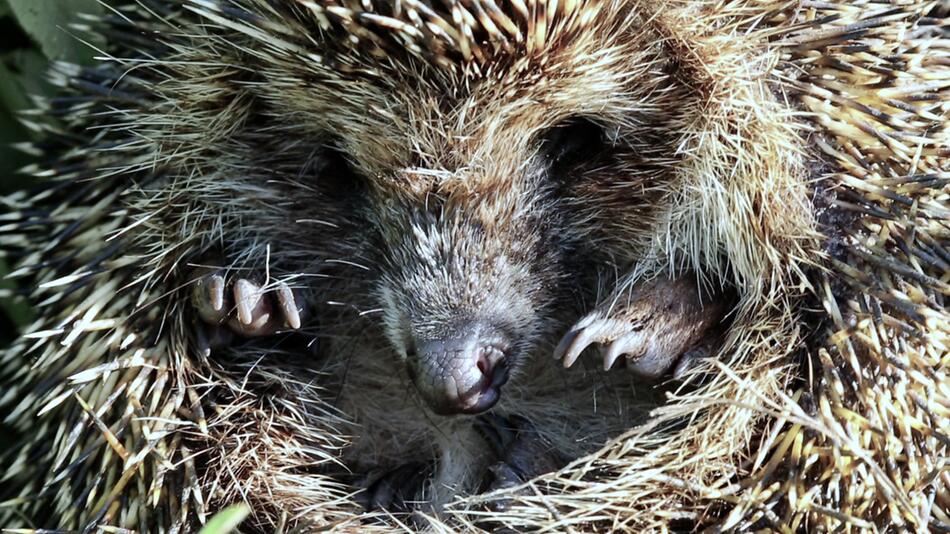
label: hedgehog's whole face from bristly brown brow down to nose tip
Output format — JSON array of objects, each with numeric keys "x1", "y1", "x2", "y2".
[{"x1": 253, "y1": 4, "x2": 681, "y2": 413}]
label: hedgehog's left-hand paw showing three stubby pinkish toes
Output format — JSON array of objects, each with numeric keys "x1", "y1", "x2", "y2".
[{"x1": 191, "y1": 271, "x2": 306, "y2": 346}]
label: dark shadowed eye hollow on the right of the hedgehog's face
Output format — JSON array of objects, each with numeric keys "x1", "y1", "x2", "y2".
[{"x1": 541, "y1": 117, "x2": 607, "y2": 174}]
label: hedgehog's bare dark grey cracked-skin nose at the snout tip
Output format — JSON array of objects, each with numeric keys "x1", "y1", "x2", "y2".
[{"x1": 407, "y1": 325, "x2": 509, "y2": 415}]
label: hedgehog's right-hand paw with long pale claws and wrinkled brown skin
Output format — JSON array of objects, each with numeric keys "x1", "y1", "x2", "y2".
[{"x1": 554, "y1": 277, "x2": 730, "y2": 378}]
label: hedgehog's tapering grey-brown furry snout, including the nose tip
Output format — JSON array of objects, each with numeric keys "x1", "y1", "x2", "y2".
[{"x1": 372, "y1": 141, "x2": 568, "y2": 413}]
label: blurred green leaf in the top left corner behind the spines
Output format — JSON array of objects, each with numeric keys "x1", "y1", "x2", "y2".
[{"x1": 6, "y1": 0, "x2": 102, "y2": 64}]
